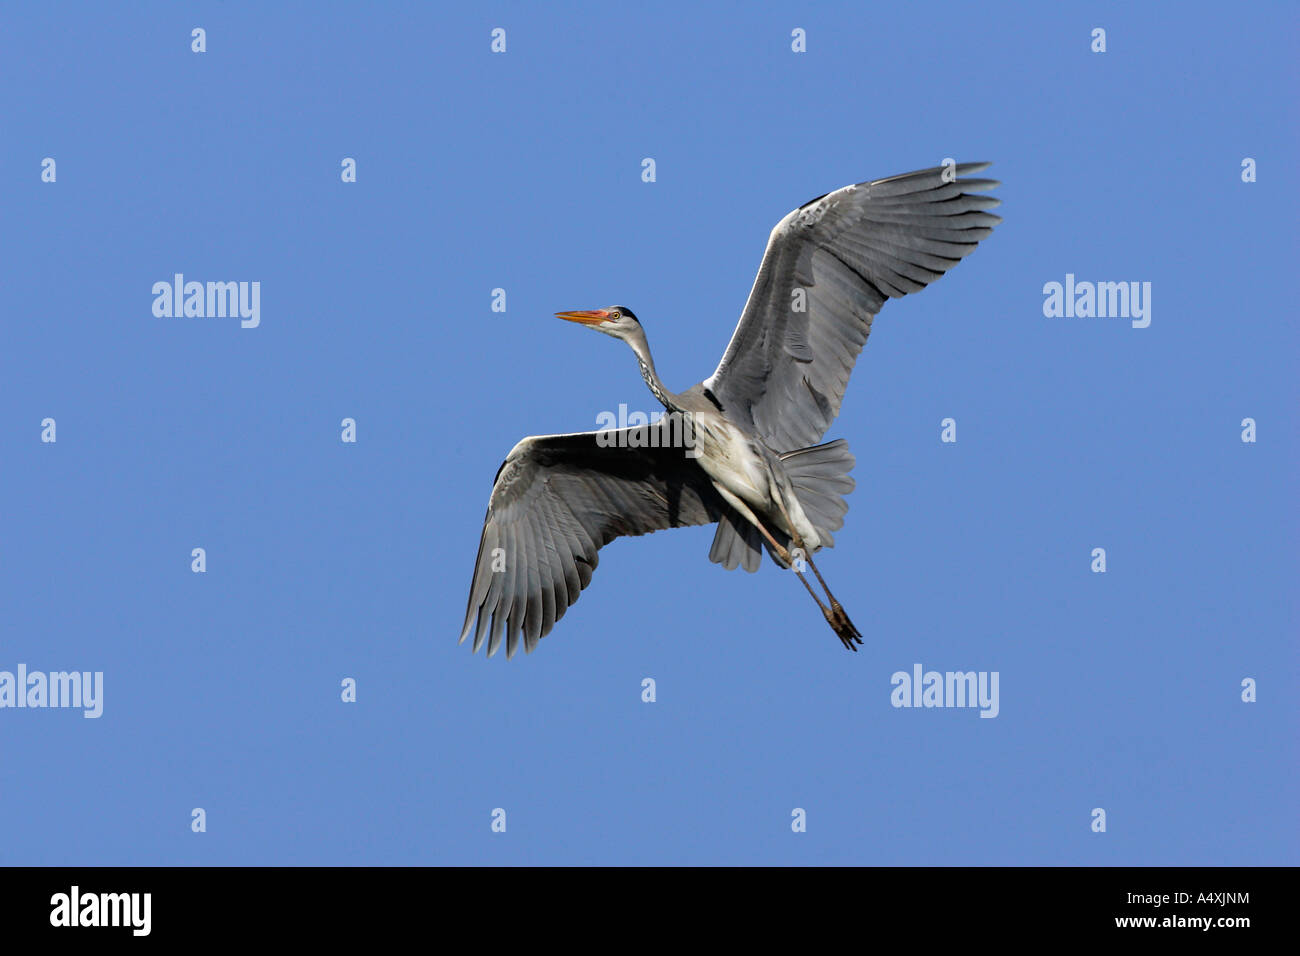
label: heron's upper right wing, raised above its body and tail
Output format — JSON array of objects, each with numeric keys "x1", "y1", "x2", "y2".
[{"x1": 703, "y1": 163, "x2": 1002, "y2": 451}]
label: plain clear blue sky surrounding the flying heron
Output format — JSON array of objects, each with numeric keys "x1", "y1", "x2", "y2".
[{"x1": 0, "y1": 3, "x2": 1300, "y2": 865}]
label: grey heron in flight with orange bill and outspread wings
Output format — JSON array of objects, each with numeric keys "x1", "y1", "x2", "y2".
[{"x1": 460, "y1": 163, "x2": 1002, "y2": 658}]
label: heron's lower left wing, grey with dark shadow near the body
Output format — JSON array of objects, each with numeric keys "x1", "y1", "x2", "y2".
[{"x1": 460, "y1": 423, "x2": 724, "y2": 658}]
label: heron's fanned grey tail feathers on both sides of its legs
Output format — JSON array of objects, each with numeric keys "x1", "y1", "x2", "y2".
[{"x1": 709, "y1": 438, "x2": 855, "y2": 571}]
